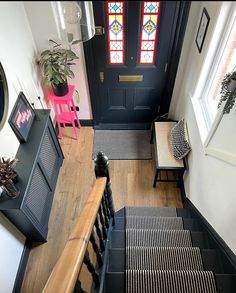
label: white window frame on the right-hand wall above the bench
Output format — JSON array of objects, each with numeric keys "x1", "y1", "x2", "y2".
[{"x1": 192, "y1": 2, "x2": 236, "y2": 154}]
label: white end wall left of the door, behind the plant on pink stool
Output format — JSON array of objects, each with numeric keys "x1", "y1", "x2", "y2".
[{"x1": 24, "y1": 1, "x2": 92, "y2": 119}]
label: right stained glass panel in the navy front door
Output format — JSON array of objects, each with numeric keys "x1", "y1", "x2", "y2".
[{"x1": 139, "y1": 1, "x2": 160, "y2": 64}]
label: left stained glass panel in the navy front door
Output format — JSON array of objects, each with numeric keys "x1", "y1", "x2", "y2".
[{"x1": 106, "y1": 1, "x2": 124, "y2": 64}]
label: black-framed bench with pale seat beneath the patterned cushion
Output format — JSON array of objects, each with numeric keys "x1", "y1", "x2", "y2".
[{"x1": 153, "y1": 121, "x2": 186, "y2": 187}]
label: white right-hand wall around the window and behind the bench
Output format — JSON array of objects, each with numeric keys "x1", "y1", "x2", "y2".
[{"x1": 170, "y1": 1, "x2": 236, "y2": 253}]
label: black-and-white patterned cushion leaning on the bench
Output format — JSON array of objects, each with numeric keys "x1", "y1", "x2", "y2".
[{"x1": 170, "y1": 119, "x2": 191, "y2": 160}]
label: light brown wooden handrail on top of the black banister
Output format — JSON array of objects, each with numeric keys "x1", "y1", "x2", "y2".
[{"x1": 43, "y1": 177, "x2": 106, "y2": 293}]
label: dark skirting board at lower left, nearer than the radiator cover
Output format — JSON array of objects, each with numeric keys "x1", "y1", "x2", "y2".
[{"x1": 12, "y1": 239, "x2": 32, "y2": 293}]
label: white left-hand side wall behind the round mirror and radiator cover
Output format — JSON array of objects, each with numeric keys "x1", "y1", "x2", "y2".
[{"x1": 0, "y1": 2, "x2": 42, "y2": 293}]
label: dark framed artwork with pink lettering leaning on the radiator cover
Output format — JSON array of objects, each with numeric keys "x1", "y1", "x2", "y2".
[{"x1": 8, "y1": 92, "x2": 35, "y2": 142}]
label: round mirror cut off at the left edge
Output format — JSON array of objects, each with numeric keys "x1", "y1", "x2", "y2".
[{"x1": 0, "y1": 63, "x2": 8, "y2": 130}]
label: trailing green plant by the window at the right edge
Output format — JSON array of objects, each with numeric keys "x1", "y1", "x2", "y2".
[{"x1": 218, "y1": 71, "x2": 236, "y2": 114}]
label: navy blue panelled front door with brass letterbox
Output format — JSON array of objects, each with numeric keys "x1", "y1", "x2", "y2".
[{"x1": 86, "y1": 1, "x2": 186, "y2": 129}]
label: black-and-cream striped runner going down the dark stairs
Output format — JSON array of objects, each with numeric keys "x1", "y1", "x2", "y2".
[{"x1": 126, "y1": 207, "x2": 217, "y2": 293}]
